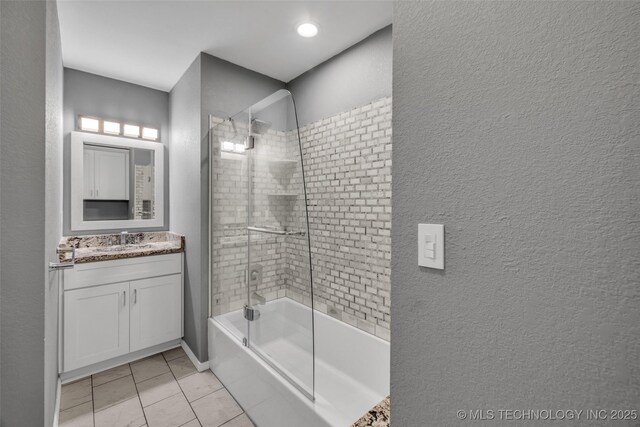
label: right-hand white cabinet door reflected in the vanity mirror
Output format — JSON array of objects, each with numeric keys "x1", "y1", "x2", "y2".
[{"x1": 93, "y1": 149, "x2": 129, "y2": 200}]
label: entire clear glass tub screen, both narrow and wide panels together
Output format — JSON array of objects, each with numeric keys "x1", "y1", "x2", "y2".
[{"x1": 209, "y1": 90, "x2": 315, "y2": 401}]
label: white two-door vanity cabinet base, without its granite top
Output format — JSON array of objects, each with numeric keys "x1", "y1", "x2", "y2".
[{"x1": 61, "y1": 253, "x2": 183, "y2": 372}]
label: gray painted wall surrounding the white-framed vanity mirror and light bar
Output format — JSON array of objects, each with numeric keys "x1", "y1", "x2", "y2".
[{"x1": 64, "y1": 68, "x2": 170, "y2": 236}]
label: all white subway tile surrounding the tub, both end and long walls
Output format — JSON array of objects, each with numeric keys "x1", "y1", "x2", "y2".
[{"x1": 212, "y1": 97, "x2": 391, "y2": 340}]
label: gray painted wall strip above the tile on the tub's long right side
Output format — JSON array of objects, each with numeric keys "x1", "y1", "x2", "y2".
[{"x1": 287, "y1": 26, "x2": 393, "y2": 126}]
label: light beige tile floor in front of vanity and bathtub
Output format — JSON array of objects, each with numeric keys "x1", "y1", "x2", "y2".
[{"x1": 59, "y1": 348, "x2": 253, "y2": 427}]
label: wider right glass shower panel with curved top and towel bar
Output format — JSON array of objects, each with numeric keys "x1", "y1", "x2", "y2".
[{"x1": 245, "y1": 90, "x2": 314, "y2": 399}]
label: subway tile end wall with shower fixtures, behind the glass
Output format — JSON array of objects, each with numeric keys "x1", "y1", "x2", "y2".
[{"x1": 211, "y1": 118, "x2": 287, "y2": 316}]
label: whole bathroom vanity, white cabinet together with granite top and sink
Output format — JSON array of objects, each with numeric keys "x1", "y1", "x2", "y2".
[{"x1": 59, "y1": 232, "x2": 184, "y2": 381}]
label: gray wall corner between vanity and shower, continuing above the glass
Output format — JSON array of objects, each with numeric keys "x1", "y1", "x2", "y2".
[{"x1": 169, "y1": 54, "x2": 284, "y2": 361}]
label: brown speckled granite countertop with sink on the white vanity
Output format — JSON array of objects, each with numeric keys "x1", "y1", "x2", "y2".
[{"x1": 58, "y1": 231, "x2": 184, "y2": 264}]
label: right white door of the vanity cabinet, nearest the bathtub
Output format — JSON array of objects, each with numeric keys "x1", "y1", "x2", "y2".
[{"x1": 131, "y1": 274, "x2": 182, "y2": 351}]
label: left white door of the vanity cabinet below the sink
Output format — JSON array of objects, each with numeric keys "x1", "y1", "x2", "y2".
[{"x1": 64, "y1": 282, "x2": 129, "y2": 371}]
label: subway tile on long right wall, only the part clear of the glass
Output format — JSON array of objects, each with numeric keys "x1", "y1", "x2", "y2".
[{"x1": 287, "y1": 97, "x2": 391, "y2": 340}]
